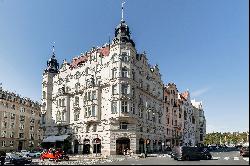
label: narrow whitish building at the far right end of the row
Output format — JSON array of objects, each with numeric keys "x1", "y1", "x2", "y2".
[{"x1": 191, "y1": 100, "x2": 206, "y2": 146}]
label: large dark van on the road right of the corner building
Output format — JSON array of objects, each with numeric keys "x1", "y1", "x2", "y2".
[{"x1": 172, "y1": 146, "x2": 201, "y2": 160}]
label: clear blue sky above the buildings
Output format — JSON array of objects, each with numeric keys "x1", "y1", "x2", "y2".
[{"x1": 0, "y1": 0, "x2": 249, "y2": 132}]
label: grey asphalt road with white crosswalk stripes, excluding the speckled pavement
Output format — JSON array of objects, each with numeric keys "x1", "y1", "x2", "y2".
[{"x1": 94, "y1": 151, "x2": 249, "y2": 165}]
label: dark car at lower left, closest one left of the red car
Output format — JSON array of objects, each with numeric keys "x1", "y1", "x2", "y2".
[{"x1": 4, "y1": 153, "x2": 32, "y2": 165}]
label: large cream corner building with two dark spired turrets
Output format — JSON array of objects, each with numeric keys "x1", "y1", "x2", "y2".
[{"x1": 42, "y1": 20, "x2": 166, "y2": 155}]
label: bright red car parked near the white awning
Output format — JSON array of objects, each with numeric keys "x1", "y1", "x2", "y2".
[{"x1": 40, "y1": 149, "x2": 69, "y2": 161}]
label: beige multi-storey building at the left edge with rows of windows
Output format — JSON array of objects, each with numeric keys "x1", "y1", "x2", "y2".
[{"x1": 0, "y1": 88, "x2": 42, "y2": 151}]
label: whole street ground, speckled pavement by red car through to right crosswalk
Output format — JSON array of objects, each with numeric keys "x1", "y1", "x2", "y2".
[{"x1": 33, "y1": 151, "x2": 249, "y2": 165}]
